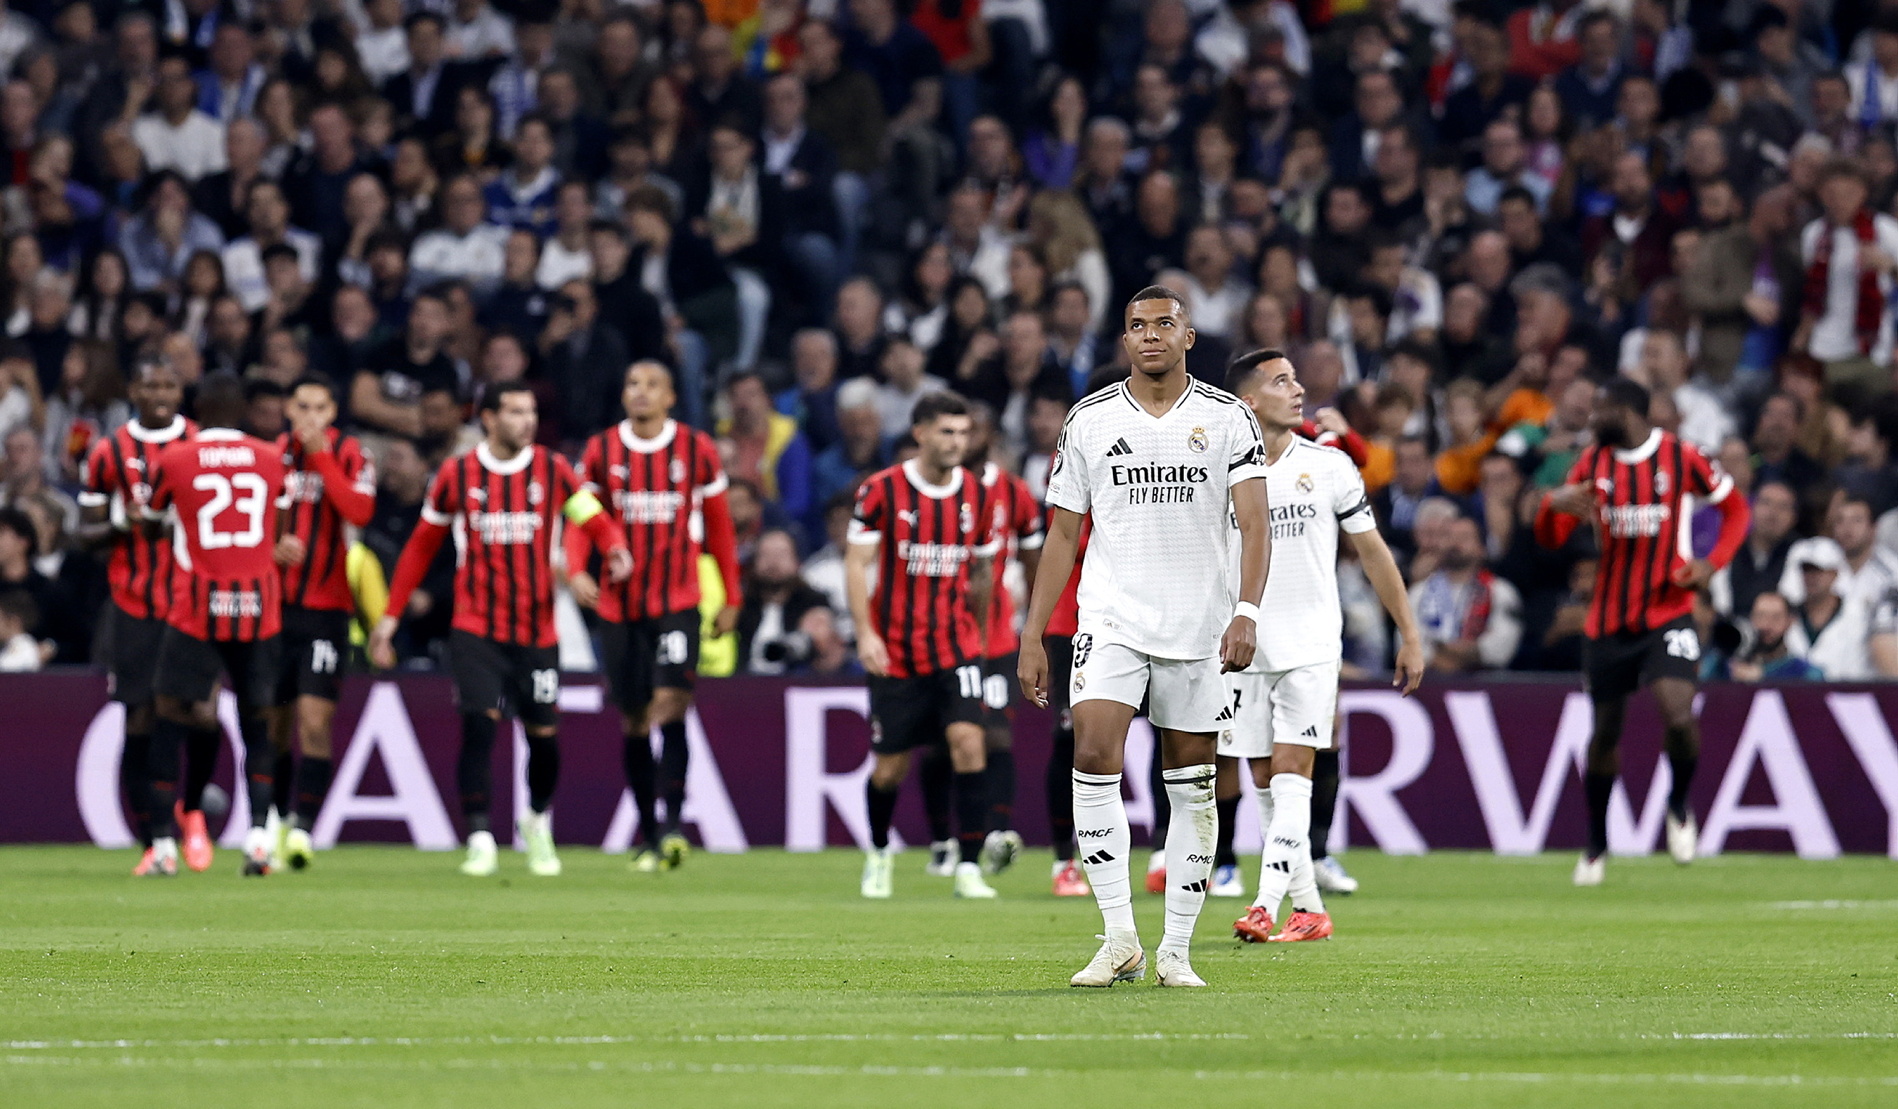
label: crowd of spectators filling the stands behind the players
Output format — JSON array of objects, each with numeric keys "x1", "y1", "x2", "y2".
[{"x1": 0, "y1": 0, "x2": 1898, "y2": 680}]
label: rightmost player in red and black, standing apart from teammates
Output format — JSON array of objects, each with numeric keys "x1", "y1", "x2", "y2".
[{"x1": 1535, "y1": 378, "x2": 1752, "y2": 885}]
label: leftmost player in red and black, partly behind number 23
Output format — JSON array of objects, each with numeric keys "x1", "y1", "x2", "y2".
[{"x1": 80, "y1": 359, "x2": 196, "y2": 877}]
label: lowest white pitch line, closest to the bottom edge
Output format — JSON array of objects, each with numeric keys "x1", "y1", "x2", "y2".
[{"x1": 0, "y1": 1054, "x2": 1898, "y2": 1088}]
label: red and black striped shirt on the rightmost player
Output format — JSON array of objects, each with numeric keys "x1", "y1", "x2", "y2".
[{"x1": 1562, "y1": 427, "x2": 1733, "y2": 638}]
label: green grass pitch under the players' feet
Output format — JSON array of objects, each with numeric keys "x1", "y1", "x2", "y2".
[{"x1": 0, "y1": 847, "x2": 1898, "y2": 1109}]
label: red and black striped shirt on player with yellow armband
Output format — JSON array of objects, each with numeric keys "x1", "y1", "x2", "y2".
[{"x1": 423, "y1": 442, "x2": 581, "y2": 648}]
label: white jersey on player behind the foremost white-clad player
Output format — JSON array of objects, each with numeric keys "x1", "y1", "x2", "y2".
[{"x1": 1232, "y1": 435, "x2": 1378, "y2": 672}]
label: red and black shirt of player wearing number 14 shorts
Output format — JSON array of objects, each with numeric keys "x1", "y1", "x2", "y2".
[{"x1": 277, "y1": 427, "x2": 376, "y2": 611}]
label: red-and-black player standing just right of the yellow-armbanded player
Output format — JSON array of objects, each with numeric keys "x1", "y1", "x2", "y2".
[{"x1": 566, "y1": 361, "x2": 742, "y2": 872}]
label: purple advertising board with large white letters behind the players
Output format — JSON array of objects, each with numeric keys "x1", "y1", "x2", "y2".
[{"x1": 0, "y1": 672, "x2": 1898, "y2": 858}]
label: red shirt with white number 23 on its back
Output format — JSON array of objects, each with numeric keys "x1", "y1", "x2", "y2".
[{"x1": 150, "y1": 427, "x2": 287, "y2": 642}]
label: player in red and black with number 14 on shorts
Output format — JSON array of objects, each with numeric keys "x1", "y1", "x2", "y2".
[{"x1": 270, "y1": 376, "x2": 376, "y2": 870}]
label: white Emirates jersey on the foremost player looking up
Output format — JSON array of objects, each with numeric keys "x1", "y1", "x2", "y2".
[{"x1": 1048, "y1": 380, "x2": 1266, "y2": 659}]
